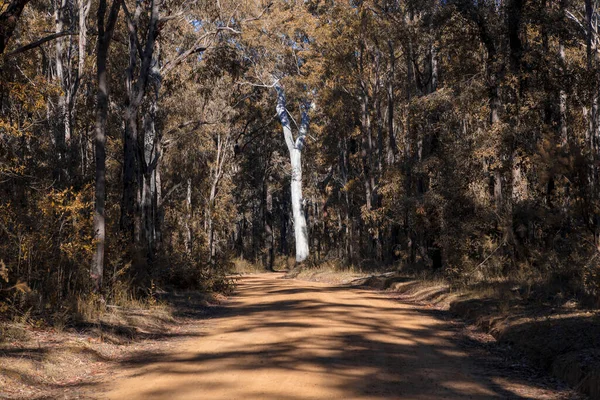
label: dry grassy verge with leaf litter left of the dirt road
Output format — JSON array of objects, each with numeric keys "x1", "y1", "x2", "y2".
[{"x1": 0, "y1": 292, "x2": 224, "y2": 399}]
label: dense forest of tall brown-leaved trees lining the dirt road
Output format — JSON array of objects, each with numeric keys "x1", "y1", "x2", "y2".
[{"x1": 0, "y1": 0, "x2": 600, "y2": 317}]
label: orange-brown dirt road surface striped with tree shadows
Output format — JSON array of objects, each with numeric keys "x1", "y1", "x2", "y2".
[{"x1": 102, "y1": 274, "x2": 576, "y2": 400}]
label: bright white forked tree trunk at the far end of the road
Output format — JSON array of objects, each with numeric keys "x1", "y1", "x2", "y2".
[{"x1": 275, "y1": 83, "x2": 309, "y2": 262}]
